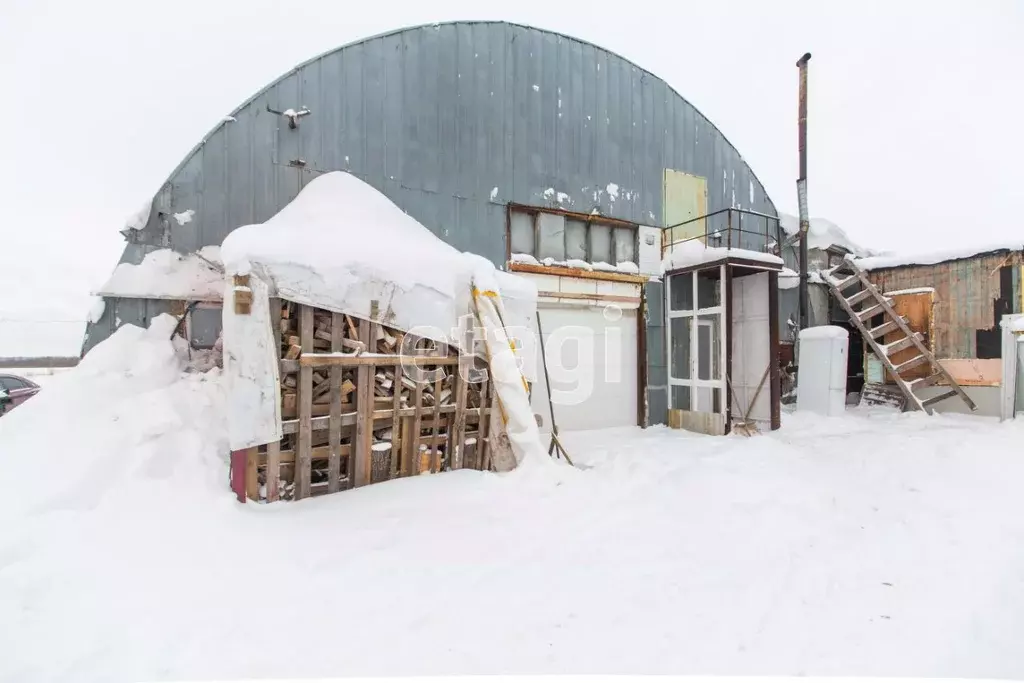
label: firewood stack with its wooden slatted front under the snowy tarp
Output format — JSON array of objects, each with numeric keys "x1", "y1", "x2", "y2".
[{"x1": 246, "y1": 299, "x2": 494, "y2": 501}]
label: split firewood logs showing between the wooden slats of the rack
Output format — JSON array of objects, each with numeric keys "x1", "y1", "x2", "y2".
[{"x1": 258, "y1": 299, "x2": 493, "y2": 501}]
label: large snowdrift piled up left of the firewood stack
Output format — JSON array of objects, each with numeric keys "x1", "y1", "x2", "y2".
[{"x1": 0, "y1": 314, "x2": 227, "y2": 520}]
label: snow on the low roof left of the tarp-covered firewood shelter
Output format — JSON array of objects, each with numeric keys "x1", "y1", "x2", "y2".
[{"x1": 96, "y1": 247, "x2": 224, "y2": 301}]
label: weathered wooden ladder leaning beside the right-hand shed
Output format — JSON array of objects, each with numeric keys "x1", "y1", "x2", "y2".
[{"x1": 822, "y1": 257, "x2": 978, "y2": 415}]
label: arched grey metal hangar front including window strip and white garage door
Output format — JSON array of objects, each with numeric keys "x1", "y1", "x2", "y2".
[{"x1": 85, "y1": 23, "x2": 779, "y2": 428}]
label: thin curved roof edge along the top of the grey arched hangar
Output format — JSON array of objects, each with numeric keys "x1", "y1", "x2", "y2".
[{"x1": 154, "y1": 19, "x2": 778, "y2": 212}]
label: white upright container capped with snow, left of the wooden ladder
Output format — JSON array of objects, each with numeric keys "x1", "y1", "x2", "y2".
[{"x1": 797, "y1": 325, "x2": 850, "y2": 415}]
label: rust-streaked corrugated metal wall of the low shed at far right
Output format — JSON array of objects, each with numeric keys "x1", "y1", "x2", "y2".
[{"x1": 868, "y1": 252, "x2": 1022, "y2": 358}]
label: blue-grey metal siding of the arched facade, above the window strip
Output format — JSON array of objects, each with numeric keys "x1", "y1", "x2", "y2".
[{"x1": 90, "y1": 23, "x2": 775, "y2": 421}]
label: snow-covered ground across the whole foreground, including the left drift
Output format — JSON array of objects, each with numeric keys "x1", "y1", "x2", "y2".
[{"x1": 0, "y1": 318, "x2": 1024, "y2": 682}]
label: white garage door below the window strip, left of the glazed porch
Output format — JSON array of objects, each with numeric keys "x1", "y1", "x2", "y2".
[{"x1": 531, "y1": 303, "x2": 637, "y2": 432}]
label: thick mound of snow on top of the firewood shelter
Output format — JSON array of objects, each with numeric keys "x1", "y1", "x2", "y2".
[{"x1": 221, "y1": 171, "x2": 537, "y2": 336}]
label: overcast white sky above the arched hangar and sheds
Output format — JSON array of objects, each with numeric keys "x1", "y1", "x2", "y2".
[{"x1": 0, "y1": 0, "x2": 1024, "y2": 317}]
